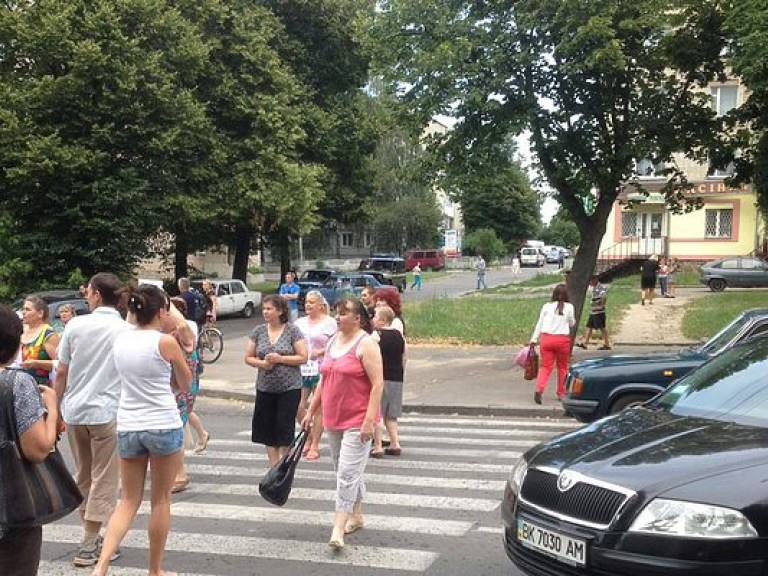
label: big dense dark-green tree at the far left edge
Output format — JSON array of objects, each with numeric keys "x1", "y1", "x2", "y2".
[{"x1": 0, "y1": 0, "x2": 208, "y2": 286}]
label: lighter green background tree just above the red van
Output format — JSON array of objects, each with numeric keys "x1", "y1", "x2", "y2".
[{"x1": 366, "y1": 127, "x2": 443, "y2": 253}]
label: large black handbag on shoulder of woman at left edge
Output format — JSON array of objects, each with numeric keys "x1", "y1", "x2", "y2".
[{"x1": 0, "y1": 370, "x2": 83, "y2": 528}]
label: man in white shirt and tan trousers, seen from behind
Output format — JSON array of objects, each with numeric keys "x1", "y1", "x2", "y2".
[{"x1": 55, "y1": 273, "x2": 131, "y2": 566}]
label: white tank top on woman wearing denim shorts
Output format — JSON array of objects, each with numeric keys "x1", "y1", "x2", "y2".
[{"x1": 114, "y1": 330, "x2": 182, "y2": 432}]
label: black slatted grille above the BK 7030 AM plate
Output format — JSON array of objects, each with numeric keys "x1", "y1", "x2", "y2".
[{"x1": 520, "y1": 468, "x2": 629, "y2": 528}]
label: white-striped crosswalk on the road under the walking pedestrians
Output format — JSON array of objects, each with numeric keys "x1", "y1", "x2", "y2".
[{"x1": 39, "y1": 414, "x2": 575, "y2": 576}]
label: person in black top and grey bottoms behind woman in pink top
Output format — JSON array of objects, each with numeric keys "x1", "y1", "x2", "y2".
[{"x1": 371, "y1": 306, "x2": 406, "y2": 458}]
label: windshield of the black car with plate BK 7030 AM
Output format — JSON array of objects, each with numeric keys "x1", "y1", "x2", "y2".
[{"x1": 648, "y1": 338, "x2": 768, "y2": 428}]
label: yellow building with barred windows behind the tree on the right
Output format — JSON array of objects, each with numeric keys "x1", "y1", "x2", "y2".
[{"x1": 598, "y1": 81, "x2": 764, "y2": 269}]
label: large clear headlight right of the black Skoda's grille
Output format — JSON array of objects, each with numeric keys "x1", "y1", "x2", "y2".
[{"x1": 629, "y1": 498, "x2": 757, "y2": 538}]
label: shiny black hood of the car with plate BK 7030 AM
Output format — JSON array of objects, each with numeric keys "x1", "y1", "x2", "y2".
[{"x1": 528, "y1": 408, "x2": 768, "y2": 508}]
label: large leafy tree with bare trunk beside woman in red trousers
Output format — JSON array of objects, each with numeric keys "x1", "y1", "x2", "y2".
[{"x1": 376, "y1": 0, "x2": 723, "y2": 324}]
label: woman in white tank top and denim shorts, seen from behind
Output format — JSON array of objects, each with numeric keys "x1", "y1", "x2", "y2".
[{"x1": 93, "y1": 285, "x2": 192, "y2": 576}]
